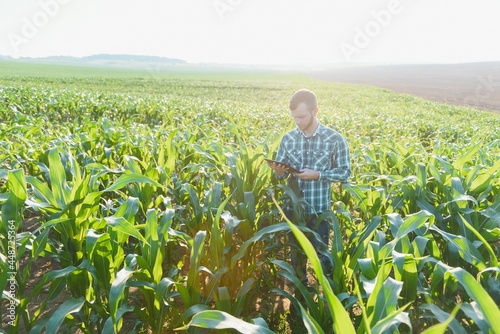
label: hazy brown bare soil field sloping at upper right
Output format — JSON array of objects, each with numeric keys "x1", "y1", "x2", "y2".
[{"x1": 310, "y1": 62, "x2": 500, "y2": 113}]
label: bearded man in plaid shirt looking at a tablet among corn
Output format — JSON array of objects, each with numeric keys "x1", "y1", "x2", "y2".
[{"x1": 268, "y1": 89, "x2": 351, "y2": 285}]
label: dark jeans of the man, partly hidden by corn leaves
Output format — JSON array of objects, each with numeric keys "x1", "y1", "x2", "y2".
[{"x1": 285, "y1": 210, "x2": 332, "y2": 283}]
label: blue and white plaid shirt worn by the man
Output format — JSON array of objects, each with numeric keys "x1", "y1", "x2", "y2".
[{"x1": 276, "y1": 124, "x2": 351, "y2": 215}]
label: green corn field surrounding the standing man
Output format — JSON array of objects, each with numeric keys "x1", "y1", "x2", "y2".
[{"x1": 0, "y1": 68, "x2": 500, "y2": 334}]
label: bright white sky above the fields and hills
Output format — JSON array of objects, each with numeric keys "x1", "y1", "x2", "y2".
[{"x1": 0, "y1": 0, "x2": 500, "y2": 65}]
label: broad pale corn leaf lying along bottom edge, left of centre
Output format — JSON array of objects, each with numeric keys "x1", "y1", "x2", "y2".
[{"x1": 175, "y1": 310, "x2": 273, "y2": 334}]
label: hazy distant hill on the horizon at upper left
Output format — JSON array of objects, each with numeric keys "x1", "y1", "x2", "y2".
[{"x1": 0, "y1": 54, "x2": 186, "y2": 68}]
